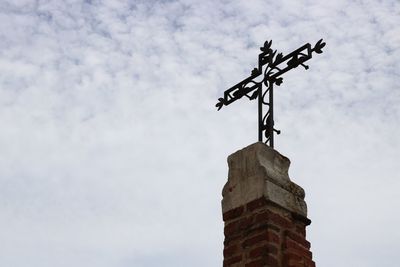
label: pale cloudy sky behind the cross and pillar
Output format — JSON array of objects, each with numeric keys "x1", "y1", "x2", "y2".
[{"x1": 0, "y1": 0, "x2": 400, "y2": 267}]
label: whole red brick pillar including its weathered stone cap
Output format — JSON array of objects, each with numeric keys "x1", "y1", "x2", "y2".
[{"x1": 222, "y1": 142, "x2": 315, "y2": 267}]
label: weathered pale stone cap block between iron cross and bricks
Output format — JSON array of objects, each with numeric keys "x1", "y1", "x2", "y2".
[{"x1": 222, "y1": 142, "x2": 307, "y2": 217}]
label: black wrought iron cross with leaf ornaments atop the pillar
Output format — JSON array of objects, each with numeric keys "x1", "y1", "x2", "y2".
[{"x1": 215, "y1": 39, "x2": 326, "y2": 148}]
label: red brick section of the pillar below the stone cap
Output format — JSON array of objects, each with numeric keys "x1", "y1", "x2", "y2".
[{"x1": 223, "y1": 198, "x2": 315, "y2": 267}]
